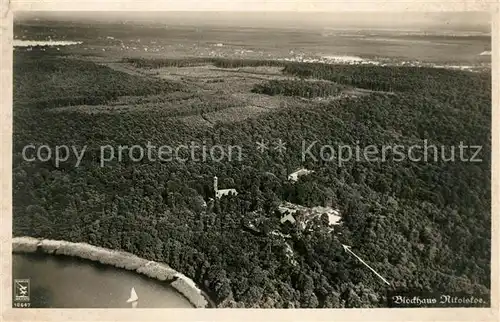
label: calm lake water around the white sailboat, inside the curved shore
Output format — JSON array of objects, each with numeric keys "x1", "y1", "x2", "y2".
[{"x1": 12, "y1": 254, "x2": 193, "y2": 308}]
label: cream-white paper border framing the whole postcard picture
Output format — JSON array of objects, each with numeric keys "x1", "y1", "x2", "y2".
[{"x1": 0, "y1": 0, "x2": 500, "y2": 322}]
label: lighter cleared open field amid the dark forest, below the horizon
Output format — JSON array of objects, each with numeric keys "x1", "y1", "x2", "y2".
[{"x1": 30, "y1": 55, "x2": 382, "y2": 126}]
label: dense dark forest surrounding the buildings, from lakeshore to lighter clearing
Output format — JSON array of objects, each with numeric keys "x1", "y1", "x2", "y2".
[{"x1": 13, "y1": 52, "x2": 491, "y2": 308}]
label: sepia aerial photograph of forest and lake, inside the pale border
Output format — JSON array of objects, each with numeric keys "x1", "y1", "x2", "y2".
[{"x1": 9, "y1": 11, "x2": 492, "y2": 312}]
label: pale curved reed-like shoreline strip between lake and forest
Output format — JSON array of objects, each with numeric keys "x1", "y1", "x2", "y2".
[{"x1": 12, "y1": 237, "x2": 214, "y2": 308}]
